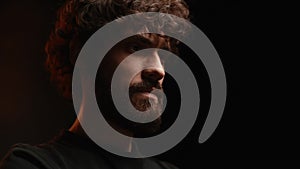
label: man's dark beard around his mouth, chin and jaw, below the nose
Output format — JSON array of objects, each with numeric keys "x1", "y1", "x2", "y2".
[{"x1": 96, "y1": 77, "x2": 164, "y2": 138}]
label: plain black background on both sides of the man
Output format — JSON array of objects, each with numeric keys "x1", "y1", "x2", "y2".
[{"x1": 0, "y1": 0, "x2": 292, "y2": 168}]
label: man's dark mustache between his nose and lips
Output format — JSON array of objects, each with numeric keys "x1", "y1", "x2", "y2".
[{"x1": 129, "y1": 81, "x2": 162, "y2": 93}]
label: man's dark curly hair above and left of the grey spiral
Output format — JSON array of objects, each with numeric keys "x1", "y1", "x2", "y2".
[{"x1": 45, "y1": 0, "x2": 189, "y2": 99}]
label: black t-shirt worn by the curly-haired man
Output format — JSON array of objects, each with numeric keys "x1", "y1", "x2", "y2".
[{"x1": 0, "y1": 131, "x2": 177, "y2": 169}]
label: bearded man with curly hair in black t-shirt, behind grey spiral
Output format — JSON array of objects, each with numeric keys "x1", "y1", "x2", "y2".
[{"x1": 0, "y1": 0, "x2": 189, "y2": 169}]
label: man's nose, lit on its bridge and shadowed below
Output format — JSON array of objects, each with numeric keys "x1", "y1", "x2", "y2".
[{"x1": 141, "y1": 53, "x2": 165, "y2": 82}]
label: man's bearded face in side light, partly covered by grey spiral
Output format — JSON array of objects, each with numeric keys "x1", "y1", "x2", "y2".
[{"x1": 96, "y1": 34, "x2": 168, "y2": 136}]
